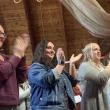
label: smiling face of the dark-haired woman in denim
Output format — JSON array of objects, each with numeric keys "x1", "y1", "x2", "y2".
[{"x1": 45, "y1": 42, "x2": 55, "y2": 60}]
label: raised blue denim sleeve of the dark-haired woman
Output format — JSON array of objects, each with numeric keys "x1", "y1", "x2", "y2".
[{"x1": 28, "y1": 64, "x2": 56, "y2": 88}]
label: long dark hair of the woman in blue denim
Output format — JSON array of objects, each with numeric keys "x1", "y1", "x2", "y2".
[{"x1": 33, "y1": 40, "x2": 48, "y2": 64}]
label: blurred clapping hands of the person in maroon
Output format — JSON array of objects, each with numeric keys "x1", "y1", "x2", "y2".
[{"x1": 13, "y1": 33, "x2": 30, "y2": 58}]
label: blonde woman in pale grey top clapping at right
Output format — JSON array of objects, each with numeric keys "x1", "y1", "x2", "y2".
[{"x1": 78, "y1": 43, "x2": 110, "y2": 110}]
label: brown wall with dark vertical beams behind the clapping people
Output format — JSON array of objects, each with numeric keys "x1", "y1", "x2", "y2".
[{"x1": 0, "y1": 0, "x2": 110, "y2": 64}]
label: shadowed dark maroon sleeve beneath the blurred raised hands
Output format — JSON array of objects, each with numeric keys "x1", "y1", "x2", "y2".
[{"x1": 16, "y1": 57, "x2": 27, "y2": 83}]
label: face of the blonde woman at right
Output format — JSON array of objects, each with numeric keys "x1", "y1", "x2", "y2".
[{"x1": 91, "y1": 44, "x2": 101, "y2": 62}]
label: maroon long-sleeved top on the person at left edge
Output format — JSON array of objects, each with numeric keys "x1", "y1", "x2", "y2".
[{"x1": 0, "y1": 55, "x2": 26, "y2": 106}]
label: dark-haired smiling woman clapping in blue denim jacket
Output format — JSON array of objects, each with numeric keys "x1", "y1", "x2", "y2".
[{"x1": 28, "y1": 40, "x2": 82, "y2": 110}]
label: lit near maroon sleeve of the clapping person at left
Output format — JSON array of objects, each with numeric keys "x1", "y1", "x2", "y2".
[{"x1": 0, "y1": 56, "x2": 20, "y2": 81}]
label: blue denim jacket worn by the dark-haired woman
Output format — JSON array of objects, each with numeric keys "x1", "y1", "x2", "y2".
[{"x1": 28, "y1": 63, "x2": 75, "y2": 110}]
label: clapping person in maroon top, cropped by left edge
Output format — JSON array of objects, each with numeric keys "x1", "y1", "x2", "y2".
[{"x1": 0, "y1": 25, "x2": 29, "y2": 110}]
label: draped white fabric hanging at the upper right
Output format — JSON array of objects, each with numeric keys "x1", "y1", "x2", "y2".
[{"x1": 60, "y1": 0, "x2": 110, "y2": 38}]
